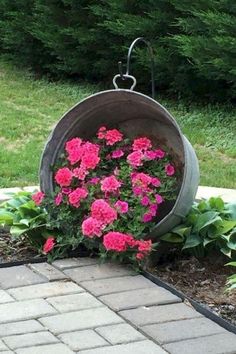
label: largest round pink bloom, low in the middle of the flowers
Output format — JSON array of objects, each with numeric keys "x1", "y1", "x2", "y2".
[{"x1": 91, "y1": 199, "x2": 117, "y2": 225}]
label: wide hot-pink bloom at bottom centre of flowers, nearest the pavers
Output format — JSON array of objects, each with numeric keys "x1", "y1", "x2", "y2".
[{"x1": 103, "y1": 231, "x2": 136, "y2": 252}]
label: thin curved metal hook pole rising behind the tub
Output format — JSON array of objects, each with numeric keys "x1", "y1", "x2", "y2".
[{"x1": 118, "y1": 37, "x2": 155, "y2": 99}]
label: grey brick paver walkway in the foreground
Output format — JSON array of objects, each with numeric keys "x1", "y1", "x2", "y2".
[{"x1": 0, "y1": 258, "x2": 236, "y2": 354}]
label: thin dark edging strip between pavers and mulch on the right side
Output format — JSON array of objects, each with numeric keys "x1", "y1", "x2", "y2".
[{"x1": 141, "y1": 270, "x2": 236, "y2": 334}]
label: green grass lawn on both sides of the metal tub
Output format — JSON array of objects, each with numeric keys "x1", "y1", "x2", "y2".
[{"x1": 0, "y1": 60, "x2": 236, "y2": 188}]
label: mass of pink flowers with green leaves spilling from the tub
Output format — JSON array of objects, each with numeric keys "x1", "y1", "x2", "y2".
[{"x1": 32, "y1": 126, "x2": 177, "y2": 262}]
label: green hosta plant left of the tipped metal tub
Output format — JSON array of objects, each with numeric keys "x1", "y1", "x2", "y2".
[{"x1": 0, "y1": 192, "x2": 49, "y2": 248}]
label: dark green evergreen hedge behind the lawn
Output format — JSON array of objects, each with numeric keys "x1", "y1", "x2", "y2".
[{"x1": 0, "y1": 0, "x2": 236, "y2": 101}]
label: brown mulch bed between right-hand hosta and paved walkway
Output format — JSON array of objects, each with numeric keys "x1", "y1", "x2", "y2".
[{"x1": 148, "y1": 255, "x2": 236, "y2": 326}]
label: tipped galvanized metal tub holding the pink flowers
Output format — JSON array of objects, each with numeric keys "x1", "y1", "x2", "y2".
[{"x1": 40, "y1": 89, "x2": 199, "y2": 239}]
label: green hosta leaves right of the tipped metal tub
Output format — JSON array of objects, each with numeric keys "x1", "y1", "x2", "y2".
[{"x1": 161, "y1": 198, "x2": 236, "y2": 258}]
